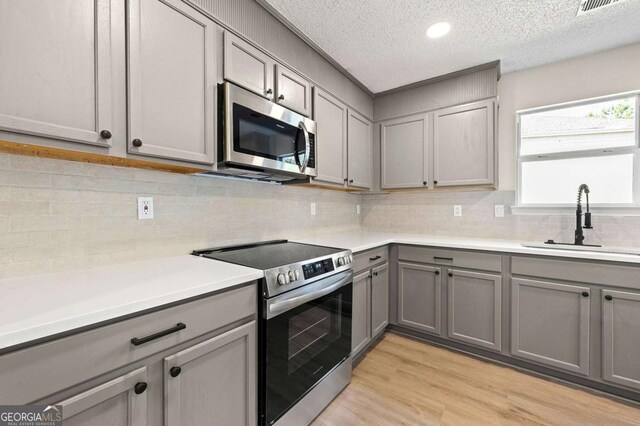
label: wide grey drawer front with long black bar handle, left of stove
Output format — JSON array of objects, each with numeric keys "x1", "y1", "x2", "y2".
[{"x1": 0, "y1": 285, "x2": 257, "y2": 404}]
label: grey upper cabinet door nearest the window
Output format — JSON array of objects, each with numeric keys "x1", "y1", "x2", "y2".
[{"x1": 433, "y1": 101, "x2": 495, "y2": 186}]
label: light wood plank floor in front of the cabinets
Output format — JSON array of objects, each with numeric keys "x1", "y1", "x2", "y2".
[{"x1": 313, "y1": 333, "x2": 640, "y2": 426}]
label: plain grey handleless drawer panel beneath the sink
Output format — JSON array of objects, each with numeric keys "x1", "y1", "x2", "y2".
[{"x1": 511, "y1": 256, "x2": 640, "y2": 289}]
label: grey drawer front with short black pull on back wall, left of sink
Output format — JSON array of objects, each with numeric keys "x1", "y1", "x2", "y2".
[{"x1": 398, "y1": 246, "x2": 502, "y2": 272}]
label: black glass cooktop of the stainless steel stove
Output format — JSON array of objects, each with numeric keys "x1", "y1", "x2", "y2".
[{"x1": 193, "y1": 240, "x2": 343, "y2": 270}]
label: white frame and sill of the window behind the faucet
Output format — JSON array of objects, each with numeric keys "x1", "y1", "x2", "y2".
[{"x1": 511, "y1": 90, "x2": 640, "y2": 216}]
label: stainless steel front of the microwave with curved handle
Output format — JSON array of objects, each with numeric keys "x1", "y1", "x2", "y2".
[{"x1": 224, "y1": 83, "x2": 316, "y2": 176}]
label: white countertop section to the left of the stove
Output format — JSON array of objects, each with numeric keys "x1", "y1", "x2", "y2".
[{"x1": 0, "y1": 255, "x2": 263, "y2": 350}]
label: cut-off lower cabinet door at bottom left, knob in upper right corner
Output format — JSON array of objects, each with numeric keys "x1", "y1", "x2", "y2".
[{"x1": 58, "y1": 367, "x2": 147, "y2": 426}]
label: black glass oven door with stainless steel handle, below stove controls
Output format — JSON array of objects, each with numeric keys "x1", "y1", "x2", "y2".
[{"x1": 260, "y1": 271, "x2": 353, "y2": 425}]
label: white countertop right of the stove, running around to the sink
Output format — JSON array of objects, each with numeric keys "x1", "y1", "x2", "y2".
[{"x1": 299, "y1": 232, "x2": 640, "y2": 264}]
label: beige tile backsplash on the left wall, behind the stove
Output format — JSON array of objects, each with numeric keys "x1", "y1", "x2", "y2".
[{"x1": 0, "y1": 154, "x2": 360, "y2": 279}]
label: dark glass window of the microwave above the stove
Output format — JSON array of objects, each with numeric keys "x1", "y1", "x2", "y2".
[{"x1": 233, "y1": 104, "x2": 305, "y2": 164}]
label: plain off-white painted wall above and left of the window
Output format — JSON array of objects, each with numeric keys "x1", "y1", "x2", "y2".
[{"x1": 498, "y1": 43, "x2": 640, "y2": 190}]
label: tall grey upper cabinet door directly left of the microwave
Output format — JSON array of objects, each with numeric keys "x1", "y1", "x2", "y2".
[{"x1": 128, "y1": 0, "x2": 216, "y2": 164}]
